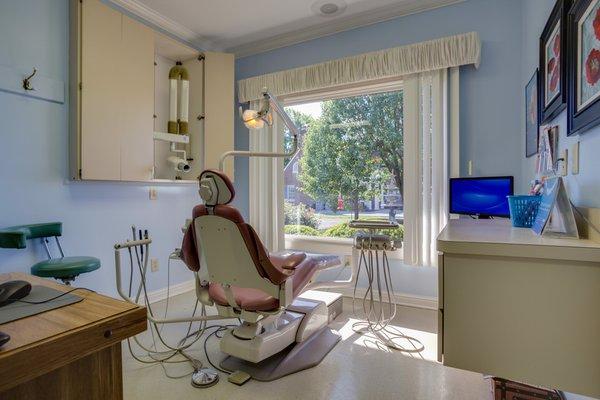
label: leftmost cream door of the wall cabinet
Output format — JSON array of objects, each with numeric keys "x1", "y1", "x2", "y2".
[{"x1": 80, "y1": 0, "x2": 123, "y2": 180}]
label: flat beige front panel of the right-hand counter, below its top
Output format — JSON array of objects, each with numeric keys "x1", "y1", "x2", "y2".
[{"x1": 443, "y1": 253, "x2": 600, "y2": 398}]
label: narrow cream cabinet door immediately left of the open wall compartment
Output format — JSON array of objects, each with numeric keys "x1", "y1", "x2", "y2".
[{"x1": 118, "y1": 15, "x2": 154, "y2": 181}]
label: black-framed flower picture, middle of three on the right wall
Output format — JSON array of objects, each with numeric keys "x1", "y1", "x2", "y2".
[{"x1": 539, "y1": 0, "x2": 571, "y2": 123}]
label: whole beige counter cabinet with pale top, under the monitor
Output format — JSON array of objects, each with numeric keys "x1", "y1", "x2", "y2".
[{"x1": 437, "y1": 219, "x2": 600, "y2": 398}]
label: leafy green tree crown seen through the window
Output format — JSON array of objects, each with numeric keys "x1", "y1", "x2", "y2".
[{"x1": 299, "y1": 92, "x2": 404, "y2": 218}]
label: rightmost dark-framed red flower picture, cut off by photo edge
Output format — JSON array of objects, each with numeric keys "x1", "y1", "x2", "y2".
[{"x1": 567, "y1": 0, "x2": 600, "y2": 135}]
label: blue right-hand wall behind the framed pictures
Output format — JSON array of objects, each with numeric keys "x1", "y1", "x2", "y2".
[{"x1": 521, "y1": 0, "x2": 600, "y2": 207}]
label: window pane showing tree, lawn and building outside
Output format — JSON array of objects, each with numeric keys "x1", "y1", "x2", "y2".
[{"x1": 284, "y1": 85, "x2": 404, "y2": 250}]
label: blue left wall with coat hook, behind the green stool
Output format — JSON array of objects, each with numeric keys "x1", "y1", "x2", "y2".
[{"x1": 0, "y1": 0, "x2": 199, "y2": 294}]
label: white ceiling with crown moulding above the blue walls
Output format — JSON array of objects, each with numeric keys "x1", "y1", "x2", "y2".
[{"x1": 108, "y1": 0, "x2": 464, "y2": 57}]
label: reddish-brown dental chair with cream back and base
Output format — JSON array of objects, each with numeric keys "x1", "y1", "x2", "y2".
[{"x1": 182, "y1": 170, "x2": 340, "y2": 381}]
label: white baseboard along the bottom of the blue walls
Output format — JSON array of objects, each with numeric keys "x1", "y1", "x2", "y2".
[{"x1": 148, "y1": 279, "x2": 438, "y2": 310}]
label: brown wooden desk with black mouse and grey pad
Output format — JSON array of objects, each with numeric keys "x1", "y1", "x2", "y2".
[{"x1": 0, "y1": 273, "x2": 146, "y2": 400}]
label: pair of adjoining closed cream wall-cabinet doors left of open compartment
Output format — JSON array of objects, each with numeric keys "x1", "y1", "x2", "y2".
[{"x1": 80, "y1": 0, "x2": 154, "y2": 181}]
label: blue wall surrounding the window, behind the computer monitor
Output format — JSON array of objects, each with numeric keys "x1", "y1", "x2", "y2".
[{"x1": 235, "y1": 0, "x2": 522, "y2": 299}]
